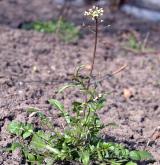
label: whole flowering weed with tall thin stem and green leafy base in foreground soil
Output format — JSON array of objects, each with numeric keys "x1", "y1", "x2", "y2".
[{"x1": 8, "y1": 6, "x2": 152, "y2": 165}]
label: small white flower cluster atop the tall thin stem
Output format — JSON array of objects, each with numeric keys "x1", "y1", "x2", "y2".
[{"x1": 84, "y1": 6, "x2": 104, "y2": 20}]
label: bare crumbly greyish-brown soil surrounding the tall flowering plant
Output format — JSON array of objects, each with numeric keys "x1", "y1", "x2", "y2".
[{"x1": 0, "y1": 0, "x2": 160, "y2": 165}]
